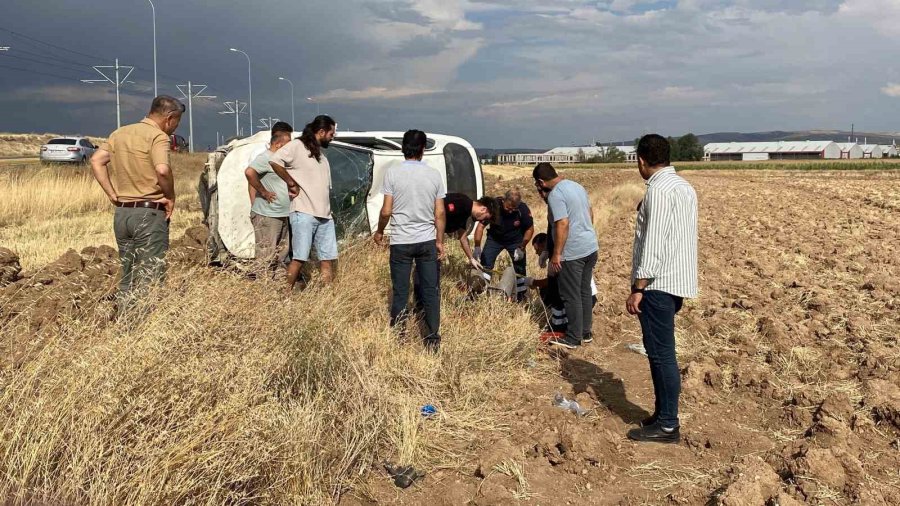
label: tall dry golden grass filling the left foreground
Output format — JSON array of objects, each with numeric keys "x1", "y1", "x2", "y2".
[{"x1": 0, "y1": 239, "x2": 537, "y2": 505}]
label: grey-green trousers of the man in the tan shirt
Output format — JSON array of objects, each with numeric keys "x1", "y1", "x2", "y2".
[{"x1": 113, "y1": 207, "x2": 169, "y2": 301}]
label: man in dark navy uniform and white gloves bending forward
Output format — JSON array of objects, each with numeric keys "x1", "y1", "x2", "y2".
[{"x1": 475, "y1": 190, "x2": 534, "y2": 301}]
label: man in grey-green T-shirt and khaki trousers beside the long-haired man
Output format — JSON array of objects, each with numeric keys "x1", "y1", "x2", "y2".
[{"x1": 244, "y1": 121, "x2": 293, "y2": 270}]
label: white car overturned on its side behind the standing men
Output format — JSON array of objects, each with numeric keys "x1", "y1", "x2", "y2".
[{"x1": 199, "y1": 131, "x2": 484, "y2": 262}]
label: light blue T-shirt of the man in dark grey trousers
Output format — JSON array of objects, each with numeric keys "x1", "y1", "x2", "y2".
[{"x1": 547, "y1": 179, "x2": 599, "y2": 260}]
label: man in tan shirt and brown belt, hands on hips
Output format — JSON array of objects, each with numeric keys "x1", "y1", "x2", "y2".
[{"x1": 91, "y1": 95, "x2": 184, "y2": 313}]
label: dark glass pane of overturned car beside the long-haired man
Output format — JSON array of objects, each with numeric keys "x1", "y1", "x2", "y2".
[{"x1": 323, "y1": 142, "x2": 375, "y2": 239}]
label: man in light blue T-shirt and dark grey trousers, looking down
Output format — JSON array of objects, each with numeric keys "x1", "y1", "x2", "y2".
[{"x1": 532, "y1": 163, "x2": 600, "y2": 349}]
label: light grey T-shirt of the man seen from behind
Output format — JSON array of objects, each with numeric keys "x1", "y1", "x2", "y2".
[{"x1": 381, "y1": 160, "x2": 446, "y2": 244}]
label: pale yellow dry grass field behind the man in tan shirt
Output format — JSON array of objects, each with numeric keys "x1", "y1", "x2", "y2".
[{"x1": 0, "y1": 154, "x2": 205, "y2": 270}]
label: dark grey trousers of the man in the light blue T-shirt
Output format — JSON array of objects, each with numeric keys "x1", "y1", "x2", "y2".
[{"x1": 557, "y1": 251, "x2": 597, "y2": 341}]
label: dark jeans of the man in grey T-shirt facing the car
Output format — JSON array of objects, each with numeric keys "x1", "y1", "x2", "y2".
[{"x1": 390, "y1": 241, "x2": 441, "y2": 340}]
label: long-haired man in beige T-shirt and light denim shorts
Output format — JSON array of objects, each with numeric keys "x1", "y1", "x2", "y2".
[{"x1": 269, "y1": 115, "x2": 338, "y2": 290}]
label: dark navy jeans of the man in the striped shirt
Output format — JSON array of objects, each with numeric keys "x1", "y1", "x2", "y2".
[{"x1": 638, "y1": 290, "x2": 683, "y2": 428}]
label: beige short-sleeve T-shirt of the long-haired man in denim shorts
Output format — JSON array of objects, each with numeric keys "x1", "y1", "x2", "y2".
[{"x1": 271, "y1": 139, "x2": 331, "y2": 219}]
